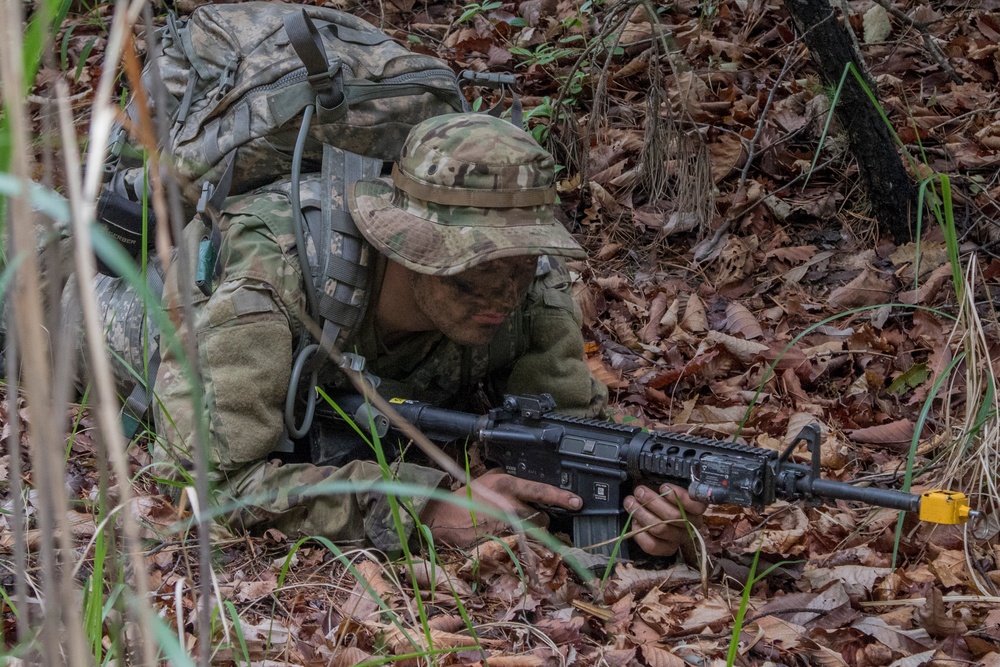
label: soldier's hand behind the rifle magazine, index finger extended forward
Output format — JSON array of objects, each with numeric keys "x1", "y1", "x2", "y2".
[{"x1": 420, "y1": 472, "x2": 583, "y2": 546}]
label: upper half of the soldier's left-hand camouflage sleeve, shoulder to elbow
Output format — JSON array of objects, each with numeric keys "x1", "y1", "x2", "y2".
[{"x1": 154, "y1": 195, "x2": 304, "y2": 470}]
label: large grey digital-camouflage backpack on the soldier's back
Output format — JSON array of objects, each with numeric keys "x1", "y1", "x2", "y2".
[{"x1": 123, "y1": 2, "x2": 462, "y2": 198}]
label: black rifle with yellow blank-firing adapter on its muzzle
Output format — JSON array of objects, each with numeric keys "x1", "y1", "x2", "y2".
[{"x1": 311, "y1": 394, "x2": 977, "y2": 555}]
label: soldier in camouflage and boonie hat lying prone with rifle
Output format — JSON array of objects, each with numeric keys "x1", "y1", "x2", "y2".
[{"x1": 113, "y1": 114, "x2": 704, "y2": 556}]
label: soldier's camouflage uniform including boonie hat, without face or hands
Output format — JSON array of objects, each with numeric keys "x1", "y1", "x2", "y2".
[{"x1": 155, "y1": 114, "x2": 607, "y2": 550}]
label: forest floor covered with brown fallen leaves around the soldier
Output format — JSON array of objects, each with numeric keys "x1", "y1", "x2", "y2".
[{"x1": 0, "y1": 0, "x2": 1000, "y2": 667}]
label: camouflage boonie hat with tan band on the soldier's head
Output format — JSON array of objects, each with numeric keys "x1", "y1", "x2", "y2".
[{"x1": 348, "y1": 114, "x2": 586, "y2": 276}]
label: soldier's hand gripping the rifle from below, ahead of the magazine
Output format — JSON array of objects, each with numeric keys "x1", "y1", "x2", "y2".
[{"x1": 624, "y1": 484, "x2": 706, "y2": 556}]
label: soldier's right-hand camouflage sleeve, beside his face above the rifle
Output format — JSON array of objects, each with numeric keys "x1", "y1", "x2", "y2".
[{"x1": 496, "y1": 260, "x2": 608, "y2": 417}]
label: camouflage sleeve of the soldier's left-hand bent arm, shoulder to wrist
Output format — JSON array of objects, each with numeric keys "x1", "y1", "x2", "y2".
[{"x1": 154, "y1": 195, "x2": 445, "y2": 550}]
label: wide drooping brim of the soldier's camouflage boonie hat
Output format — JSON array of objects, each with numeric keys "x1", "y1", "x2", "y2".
[{"x1": 347, "y1": 179, "x2": 587, "y2": 276}]
